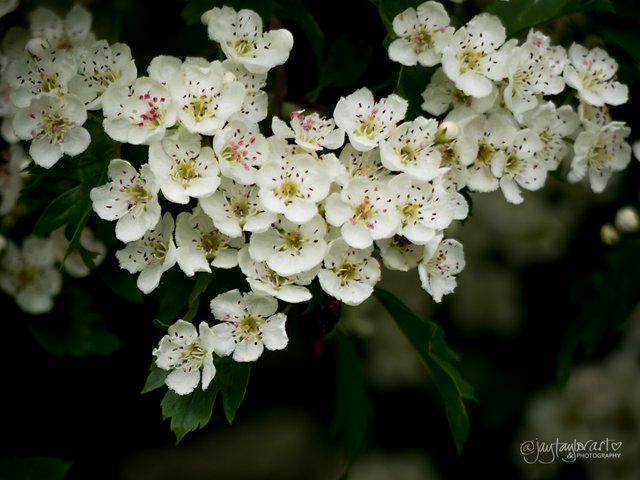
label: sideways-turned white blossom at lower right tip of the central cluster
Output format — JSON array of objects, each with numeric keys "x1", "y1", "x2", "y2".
[{"x1": 418, "y1": 236, "x2": 465, "y2": 303}]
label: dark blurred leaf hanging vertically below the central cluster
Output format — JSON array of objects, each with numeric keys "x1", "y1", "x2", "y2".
[{"x1": 327, "y1": 330, "x2": 373, "y2": 459}]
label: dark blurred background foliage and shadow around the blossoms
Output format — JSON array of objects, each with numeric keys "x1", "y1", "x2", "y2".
[{"x1": 0, "y1": 0, "x2": 640, "y2": 480}]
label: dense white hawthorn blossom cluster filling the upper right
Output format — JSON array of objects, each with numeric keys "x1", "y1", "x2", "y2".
[{"x1": 389, "y1": 1, "x2": 631, "y2": 199}]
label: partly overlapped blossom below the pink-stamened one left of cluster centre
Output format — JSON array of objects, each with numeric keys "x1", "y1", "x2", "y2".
[{"x1": 199, "y1": 177, "x2": 277, "y2": 238}]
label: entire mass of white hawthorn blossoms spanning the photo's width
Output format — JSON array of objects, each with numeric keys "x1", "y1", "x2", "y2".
[{"x1": 0, "y1": 1, "x2": 631, "y2": 395}]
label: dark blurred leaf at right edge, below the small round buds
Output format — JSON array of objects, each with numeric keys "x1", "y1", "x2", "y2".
[{"x1": 557, "y1": 240, "x2": 640, "y2": 383}]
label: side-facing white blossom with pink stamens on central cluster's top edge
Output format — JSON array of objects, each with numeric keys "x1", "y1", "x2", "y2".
[{"x1": 271, "y1": 110, "x2": 344, "y2": 152}]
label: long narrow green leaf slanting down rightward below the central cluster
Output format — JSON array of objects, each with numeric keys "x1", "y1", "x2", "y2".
[{"x1": 374, "y1": 288, "x2": 474, "y2": 455}]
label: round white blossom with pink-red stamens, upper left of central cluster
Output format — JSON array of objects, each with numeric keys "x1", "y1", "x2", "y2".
[{"x1": 102, "y1": 77, "x2": 177, "y2": 145}]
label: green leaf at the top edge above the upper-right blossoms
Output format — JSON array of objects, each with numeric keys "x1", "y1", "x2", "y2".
[{"x1": 486, "y1": 0, "x2": 613, "y2": 37}]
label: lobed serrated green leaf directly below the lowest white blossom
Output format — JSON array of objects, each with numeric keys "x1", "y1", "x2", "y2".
[{"x1": 160, "y1": 382, "x2": 218, "y2": 442}]
